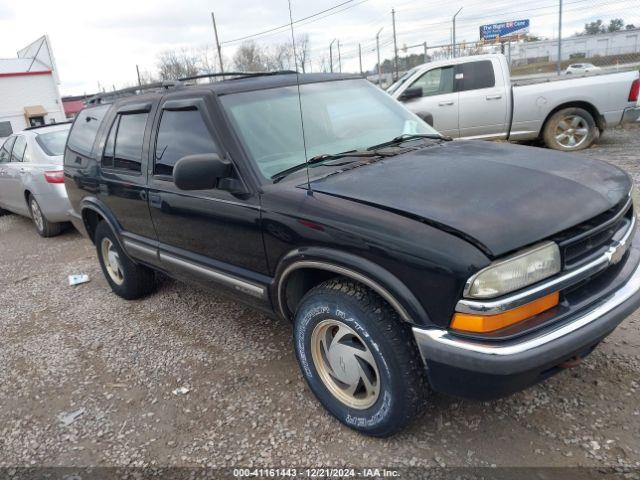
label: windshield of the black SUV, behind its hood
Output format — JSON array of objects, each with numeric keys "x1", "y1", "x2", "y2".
[{"x1": 222, "y1": 79, "x2": 437, "y2": 178}]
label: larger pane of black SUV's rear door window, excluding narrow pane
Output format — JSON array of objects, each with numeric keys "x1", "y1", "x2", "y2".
[{"x1": 113, "y1": 113, "x2": 149, "y2": 172}]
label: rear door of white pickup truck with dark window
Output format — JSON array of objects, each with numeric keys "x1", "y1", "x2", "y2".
[{"x1": 456, "y1": 58, "x2": 509, "y2": 138}]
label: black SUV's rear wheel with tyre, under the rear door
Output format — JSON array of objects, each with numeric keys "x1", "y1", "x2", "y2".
[{"x1": 95, "y1": 222, "x2": 155, "y2": 300}]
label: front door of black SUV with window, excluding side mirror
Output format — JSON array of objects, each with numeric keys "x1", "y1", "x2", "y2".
[{"x1": 149, "y1": 95, "x2": 268, "y2": 303}]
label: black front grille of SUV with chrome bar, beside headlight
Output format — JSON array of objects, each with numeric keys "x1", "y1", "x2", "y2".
[{"x1": 558, "y1": 197, "x2": 633, "y2": 270}]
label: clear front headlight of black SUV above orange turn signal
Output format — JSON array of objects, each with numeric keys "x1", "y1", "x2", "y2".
[{"x1": 465, "y1": 242, "x2": 561, "y2": 298}]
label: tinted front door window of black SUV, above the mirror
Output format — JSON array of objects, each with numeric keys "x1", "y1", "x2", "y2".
[{"x1": 154, "y1": 110, "x2": 220, "y2": 175}]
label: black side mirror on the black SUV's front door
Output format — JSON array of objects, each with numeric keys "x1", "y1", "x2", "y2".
[{"x1": 173, "y1": 153, "x2": 233, "y2": 190}]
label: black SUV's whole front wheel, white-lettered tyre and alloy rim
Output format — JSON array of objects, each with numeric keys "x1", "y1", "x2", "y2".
[{"x1": 294, "y1": 278, "x2": 427, "y2": 437}]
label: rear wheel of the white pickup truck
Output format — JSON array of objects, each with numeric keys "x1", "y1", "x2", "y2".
[{"x1": 543, "y1": 108, "x2": 600, "y2": 152}]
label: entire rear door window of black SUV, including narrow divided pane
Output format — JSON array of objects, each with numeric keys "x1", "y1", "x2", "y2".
[{"x1": 102, "y1": 112, "x2": 149, "y2": 173}]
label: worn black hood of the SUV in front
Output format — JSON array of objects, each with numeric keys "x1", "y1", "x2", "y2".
[{"x1": 312, "y1": 141, "x2": 631, "y2": 256}]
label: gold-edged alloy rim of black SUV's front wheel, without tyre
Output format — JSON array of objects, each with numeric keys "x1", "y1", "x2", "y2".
[{"x1": 311, "y1": 319, "x2": 380, "y2": 410}]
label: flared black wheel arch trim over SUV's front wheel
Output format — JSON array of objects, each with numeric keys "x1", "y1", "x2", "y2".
[{"x1": 272, "y1": 248, "x2": 429, "y2": 325}]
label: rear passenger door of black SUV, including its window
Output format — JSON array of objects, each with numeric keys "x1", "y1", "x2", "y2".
[{"x1": 98, "y1": 101, "x2": 157, "y2": 243}]
